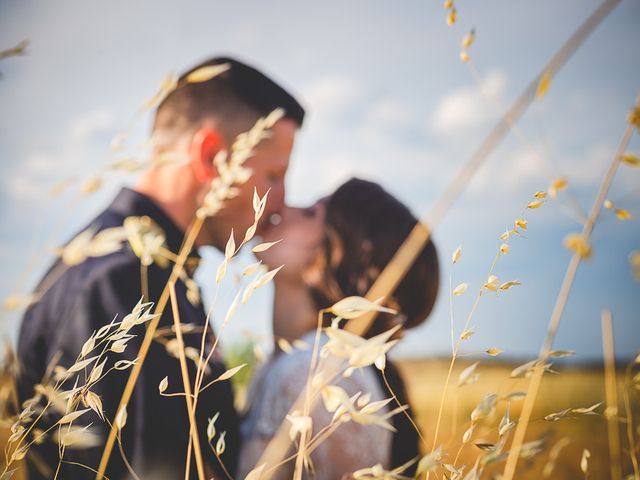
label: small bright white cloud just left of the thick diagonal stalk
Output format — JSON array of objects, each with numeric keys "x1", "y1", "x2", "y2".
[{"x1": 430, "y1": 70, "x2": 507, "y2": 136}]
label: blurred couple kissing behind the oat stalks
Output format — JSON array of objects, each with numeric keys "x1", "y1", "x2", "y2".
[{"x1": 18, "y1": 57, "x2": 439, "y2": 480}]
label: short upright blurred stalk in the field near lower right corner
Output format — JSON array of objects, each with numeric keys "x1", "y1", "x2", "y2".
[{"x1": 601, "y1": 310, "x2": 622, "y2": 480}]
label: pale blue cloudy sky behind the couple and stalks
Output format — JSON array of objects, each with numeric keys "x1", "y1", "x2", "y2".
[{"x1": 0, "y1": 0, "x2": 640, "y2": 360}]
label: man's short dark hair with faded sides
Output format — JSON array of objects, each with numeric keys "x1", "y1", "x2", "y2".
[{"x1": 153, "y1": 57, "x2": 305, "y2": 141}]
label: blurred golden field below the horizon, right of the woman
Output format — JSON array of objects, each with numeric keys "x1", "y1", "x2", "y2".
[{"x1": 398, "y1": 359, "x2": 640, "y2": 479}]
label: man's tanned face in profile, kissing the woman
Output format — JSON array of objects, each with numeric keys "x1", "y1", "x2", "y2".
[{"x1": 205, "y1": 118, "x2": 298, "y2": 249}]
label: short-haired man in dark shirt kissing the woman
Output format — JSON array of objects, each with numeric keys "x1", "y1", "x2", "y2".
[{"x1": 18, "y1": 58, "x2": 304, "y2": 480}]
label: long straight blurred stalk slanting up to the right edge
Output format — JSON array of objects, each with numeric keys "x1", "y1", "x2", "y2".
[{"x1": 503, "y1": 97, "x2": 640, "y2": 480}]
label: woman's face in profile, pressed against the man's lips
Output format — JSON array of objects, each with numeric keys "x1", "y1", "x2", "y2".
[{"x1": 256, "y1": 200, "x2": 326, "y2": 279}]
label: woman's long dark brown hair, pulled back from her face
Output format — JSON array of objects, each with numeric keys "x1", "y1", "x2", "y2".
[{"x1": 309, "y1": 178, "x2": 439, "y2": 476}]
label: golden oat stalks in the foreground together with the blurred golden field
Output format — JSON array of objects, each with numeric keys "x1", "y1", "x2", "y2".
[{"x1": 2, "y1": 1, "x2": 640, "y2": 479}]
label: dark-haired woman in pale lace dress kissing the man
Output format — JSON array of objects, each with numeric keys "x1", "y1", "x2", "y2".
[{"x1": 240, "y1": 179, "x2": 438, "y2": 479}]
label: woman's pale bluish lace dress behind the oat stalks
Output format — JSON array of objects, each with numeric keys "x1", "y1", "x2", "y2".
[{"x1": 238, "y1": 332, "x2": 393, "y2": 480}]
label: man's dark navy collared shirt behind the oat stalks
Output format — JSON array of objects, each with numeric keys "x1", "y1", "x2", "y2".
[{"x1": 18, "y1": 189, "x2": 239, "y2": 480}]
